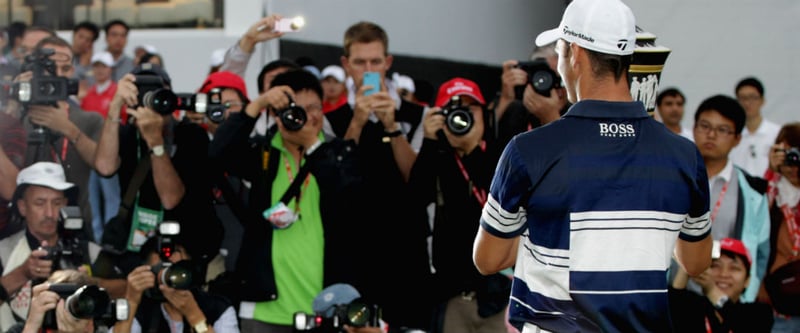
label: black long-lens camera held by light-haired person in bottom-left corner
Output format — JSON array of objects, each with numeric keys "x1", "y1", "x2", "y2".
[{"x1": 42, "y1": 283, "x2": 128, "y2": 330}]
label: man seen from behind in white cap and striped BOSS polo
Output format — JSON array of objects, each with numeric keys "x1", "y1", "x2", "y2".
[{"x1": 473, "y1": 0, "x2": 711, "y2": 333}]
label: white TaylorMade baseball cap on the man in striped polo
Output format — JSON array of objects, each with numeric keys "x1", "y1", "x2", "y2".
[{"x1": 536, "y1": 0, "x2": 636, "y2": 55}]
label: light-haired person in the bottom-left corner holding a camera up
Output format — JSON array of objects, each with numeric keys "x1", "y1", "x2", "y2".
[{"x1": 6, "y1": 269, "x2": 96, "y2": 333}]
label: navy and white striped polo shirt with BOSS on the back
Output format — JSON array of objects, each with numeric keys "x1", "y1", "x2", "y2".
[{"x1": 481, "y1": 100, "x2": 711, "y2": 332}]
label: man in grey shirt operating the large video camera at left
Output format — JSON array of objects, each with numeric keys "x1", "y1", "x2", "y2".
[{"x1": 8, "y1": 36, "x2": 102, "y2": 239}]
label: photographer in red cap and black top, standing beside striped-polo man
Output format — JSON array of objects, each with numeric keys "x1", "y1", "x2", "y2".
[{"x1": 409, "y1": 78, "x2": 511, "y2": 333}]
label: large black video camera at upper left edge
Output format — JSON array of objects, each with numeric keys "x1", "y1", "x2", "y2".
[{"x1": 0, "y1": 48, "x2": 79, "y2": 107}]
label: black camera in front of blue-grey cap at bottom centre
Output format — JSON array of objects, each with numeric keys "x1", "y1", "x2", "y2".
[{"x1": 294, "y1": 299, "x2": 381, "y2": 332}]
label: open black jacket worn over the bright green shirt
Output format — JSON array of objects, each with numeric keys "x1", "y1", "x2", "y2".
[{"x1": 209, "y1": 112, "x2": 361, "y2": 301}]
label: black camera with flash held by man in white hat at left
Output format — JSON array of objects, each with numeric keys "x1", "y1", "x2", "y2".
[{"x1": 41, "y1": 206, "x2": 91, "y2": 271}]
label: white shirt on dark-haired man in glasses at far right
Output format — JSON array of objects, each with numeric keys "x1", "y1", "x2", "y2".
[{"x1": 728, "y1": 119, "x2": 781, "y2": 178}]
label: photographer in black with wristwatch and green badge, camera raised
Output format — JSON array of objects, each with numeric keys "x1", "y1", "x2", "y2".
[{"x1": 95, "y1": 64, "x2": 223, "y2": 273}]
